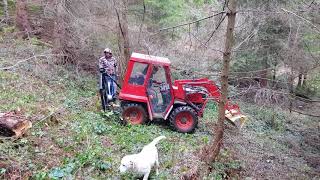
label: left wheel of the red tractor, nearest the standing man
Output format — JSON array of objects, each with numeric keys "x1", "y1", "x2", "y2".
[{"x1": 122, "y1": 103, "x2": 147, "y2": 125}]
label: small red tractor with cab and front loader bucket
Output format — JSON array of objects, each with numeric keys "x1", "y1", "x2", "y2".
[{"x1": 119, "y1": 53, "x2": 246, "y2": 133}]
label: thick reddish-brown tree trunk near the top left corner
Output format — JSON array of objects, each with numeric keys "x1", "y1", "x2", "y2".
[{"x1": 16, "y1": 0, "x2": 31, "y2": 37}]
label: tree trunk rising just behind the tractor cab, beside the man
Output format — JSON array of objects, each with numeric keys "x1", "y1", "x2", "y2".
[{"x1": 114, "y1": 0, "x2": 130, "y2": 84}]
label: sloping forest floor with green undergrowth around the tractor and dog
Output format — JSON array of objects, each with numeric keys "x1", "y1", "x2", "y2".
[{"x1": 0, "y1": 66, "x2": 320, "y2": 179}]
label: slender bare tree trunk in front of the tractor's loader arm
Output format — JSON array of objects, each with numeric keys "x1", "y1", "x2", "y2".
[{"x1": 209, "y1": 0, "x2": 237, "y2": 162}]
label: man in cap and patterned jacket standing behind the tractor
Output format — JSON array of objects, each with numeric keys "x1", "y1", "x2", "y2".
[{"x1": 99, "y1": 48, "x2": 118, "y2": 100}]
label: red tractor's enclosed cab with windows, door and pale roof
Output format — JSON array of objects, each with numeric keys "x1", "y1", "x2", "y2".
[{"x1": 119, "y1": 53, "x2": 173, "y2": 123}]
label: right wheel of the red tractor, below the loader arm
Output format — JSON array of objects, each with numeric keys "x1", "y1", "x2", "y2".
[{"x1": 169, "y1": 106, "x2": 198, "y2": 133}]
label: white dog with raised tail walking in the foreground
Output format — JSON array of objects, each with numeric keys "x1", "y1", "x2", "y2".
[{"x1": 119, "y1": 136, "x2": 166, "y2": 180}]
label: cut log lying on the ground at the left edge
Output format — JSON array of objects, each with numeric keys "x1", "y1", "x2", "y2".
[{"x1": 0, "y1": 112, "x2": 32, "y2": 137}]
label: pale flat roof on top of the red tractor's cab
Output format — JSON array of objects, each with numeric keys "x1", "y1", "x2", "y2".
[{"x1": 130, "y1": 53, "x2": 171, "y2": 66}]
